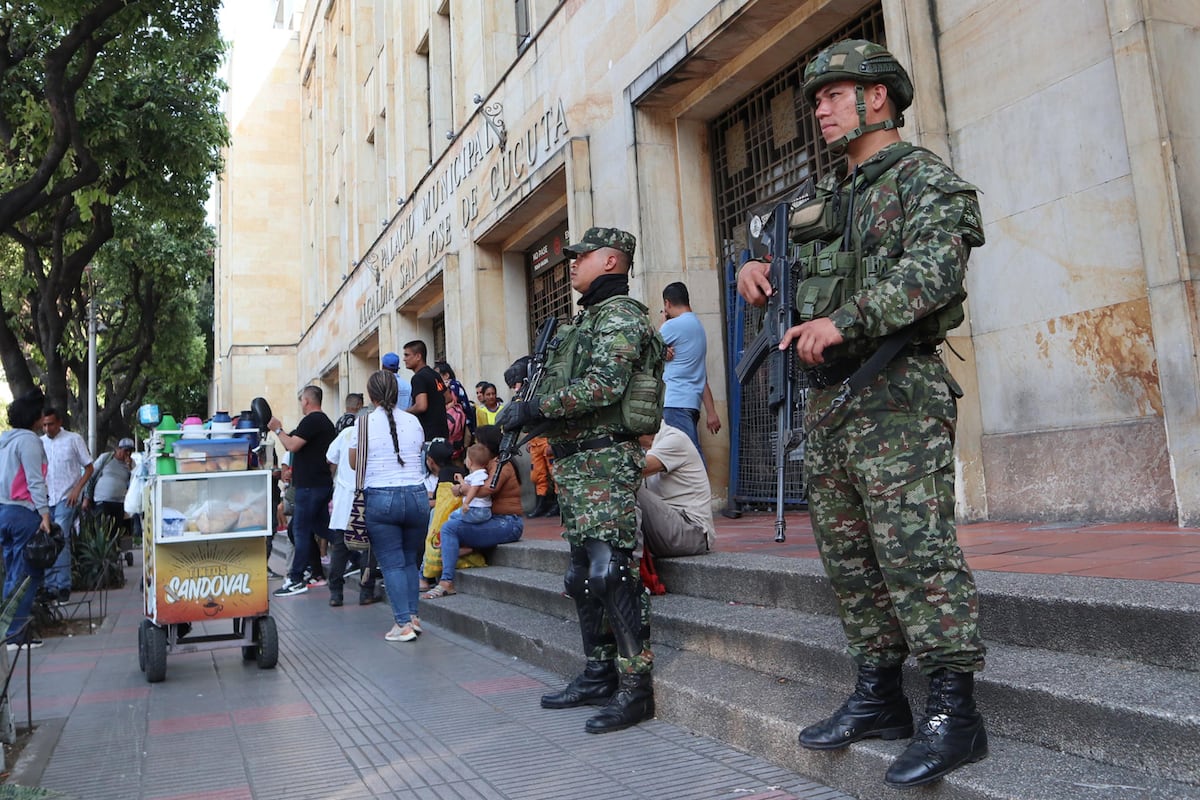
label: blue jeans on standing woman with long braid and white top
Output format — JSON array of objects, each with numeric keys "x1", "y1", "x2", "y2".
[{"x1": 364, "y1": 485, "x2": 430, "y2": 625}]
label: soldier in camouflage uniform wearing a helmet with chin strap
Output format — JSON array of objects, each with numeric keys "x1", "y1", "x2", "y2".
[{"x1": 738, "y1": 41, "x2": 988, "y2": 787}]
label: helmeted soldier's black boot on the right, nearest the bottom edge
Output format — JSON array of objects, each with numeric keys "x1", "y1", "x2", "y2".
[{"x1": 883, "y1": 669, "x2": 988, "y2": 789}]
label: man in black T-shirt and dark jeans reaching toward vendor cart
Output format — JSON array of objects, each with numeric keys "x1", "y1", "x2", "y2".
[{"x1": 266, "y1": 386, "x2": 337, "y2": 597}]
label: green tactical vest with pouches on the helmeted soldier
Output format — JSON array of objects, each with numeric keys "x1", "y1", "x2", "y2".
[{"x1": 788, "y1": 142, "x2": 964, "y2": 342}]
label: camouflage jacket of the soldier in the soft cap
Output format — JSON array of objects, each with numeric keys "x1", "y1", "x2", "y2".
[{"x1": 539, "y1": 296, "x2": 658, "y2": 441}]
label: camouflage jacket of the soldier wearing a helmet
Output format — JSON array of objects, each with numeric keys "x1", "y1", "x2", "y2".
[{"x1": 820, "y1": 145, "x2": 984, "y2": 360}]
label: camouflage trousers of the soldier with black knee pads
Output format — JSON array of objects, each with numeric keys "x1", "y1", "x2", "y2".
[{"x1": 554, "y1": 441, "x2": 654, "y2": 673}]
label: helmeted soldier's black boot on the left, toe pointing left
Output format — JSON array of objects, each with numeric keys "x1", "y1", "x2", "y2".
[{"x1": 800, "y1": 666, "x2": 912, "y2": 750}]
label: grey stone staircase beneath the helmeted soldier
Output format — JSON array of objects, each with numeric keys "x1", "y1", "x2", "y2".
[{"x1": 421, "y1": 541, "x2": 1200, "y2": 800}]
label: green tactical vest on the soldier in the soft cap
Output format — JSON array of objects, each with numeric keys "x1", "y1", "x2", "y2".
[{"x1": 538, "y1": 295, "x2": 666, "y2": 439}]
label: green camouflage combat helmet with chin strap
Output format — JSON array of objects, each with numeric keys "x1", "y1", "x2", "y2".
[{"x1": 802, "y1": 38, "x2": 912, "y2": 151}]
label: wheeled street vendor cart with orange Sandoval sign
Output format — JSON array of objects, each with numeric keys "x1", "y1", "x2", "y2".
[{"x1": 138, "y1": 410, "x2": 280, "y2": 684}]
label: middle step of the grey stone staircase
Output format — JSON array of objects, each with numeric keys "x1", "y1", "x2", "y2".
[{"x1": 451, "y1": 566, "x2": 1200, "y2": 783}]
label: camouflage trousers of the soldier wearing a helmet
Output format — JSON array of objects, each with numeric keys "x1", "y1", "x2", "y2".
[{"x1": 804, "y1": 355, "x2": 985, "y2": 675}]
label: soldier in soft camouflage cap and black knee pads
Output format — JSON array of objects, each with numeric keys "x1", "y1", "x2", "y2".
[{"x1": 497, "y1": 228, "x2": 662, "y2": 733}]
